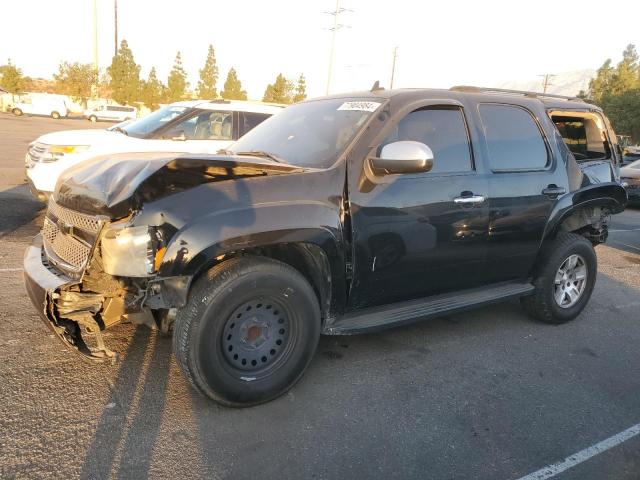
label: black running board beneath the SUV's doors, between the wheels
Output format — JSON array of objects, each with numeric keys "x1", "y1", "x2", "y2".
[{"x1": 322, "y1": 282, "x2": 534, "y2": 335}]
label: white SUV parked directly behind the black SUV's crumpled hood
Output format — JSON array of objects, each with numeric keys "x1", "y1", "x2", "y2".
[{"x1": 25, "y1": 100, "x2": 283, "y2": 201}]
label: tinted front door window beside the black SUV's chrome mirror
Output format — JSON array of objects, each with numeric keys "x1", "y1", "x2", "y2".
[{"x1": 382, "y1": 107, "x2": 473, "y2": 173}]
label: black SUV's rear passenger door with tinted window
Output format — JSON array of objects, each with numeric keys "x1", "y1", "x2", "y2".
[{"x1": 478, "y1": 103, "x2": 568, "y2": 281}]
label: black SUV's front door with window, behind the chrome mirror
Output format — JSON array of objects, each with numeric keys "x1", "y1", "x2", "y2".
[{"x1": 349, "y1": 102, "x2": 489, "y2": 308}]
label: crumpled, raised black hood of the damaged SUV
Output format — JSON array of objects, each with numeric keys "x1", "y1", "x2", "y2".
[{"x1": 54, "y1": 152, "x2": 305, "y2": 219}]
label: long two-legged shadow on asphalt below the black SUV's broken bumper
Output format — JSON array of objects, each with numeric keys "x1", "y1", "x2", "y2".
[{"x1": 80, "y1": 326, "x2": 171, "y2": 479}]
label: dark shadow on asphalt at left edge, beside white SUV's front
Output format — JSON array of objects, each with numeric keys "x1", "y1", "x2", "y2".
[{"x1": 0, "y1": 185, "x2": 45, "y2": 238}]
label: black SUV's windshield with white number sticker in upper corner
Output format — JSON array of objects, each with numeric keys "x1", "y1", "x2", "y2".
[{"x1": 230, "y1": 98, "x2": 381, "y2": 168}]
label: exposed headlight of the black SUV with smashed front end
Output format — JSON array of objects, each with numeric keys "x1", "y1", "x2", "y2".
[{"x1": 101, "y1": 226, "x2": 166, "y2": 277}]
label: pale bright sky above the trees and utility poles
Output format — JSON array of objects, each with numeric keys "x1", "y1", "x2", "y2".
[{"x1": 0, "y1": 0, "x2": 640, "y2": 99}]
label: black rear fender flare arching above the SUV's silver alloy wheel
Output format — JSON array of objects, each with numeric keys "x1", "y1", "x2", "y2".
[{"x1": 542, "y1": 182, "x2": 627, "y2": 241}]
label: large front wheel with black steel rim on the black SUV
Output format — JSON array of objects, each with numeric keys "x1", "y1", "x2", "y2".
[{"x1": 173, "y1": 256, "x2": 320, "y2": 407}]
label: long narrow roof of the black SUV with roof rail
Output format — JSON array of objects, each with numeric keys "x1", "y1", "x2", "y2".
[{"x1": 316, "y1": 86, "x2": 601, "y2": 111}]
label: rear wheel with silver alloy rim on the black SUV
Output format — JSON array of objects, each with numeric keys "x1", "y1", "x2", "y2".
[{"x1": 521, "y1": 233, "x2": 598, "y2": 325}]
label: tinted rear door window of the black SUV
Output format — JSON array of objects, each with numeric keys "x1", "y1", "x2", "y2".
[{"x1": 480, "y1": 105, "x2": 548, "y2": 170}]
